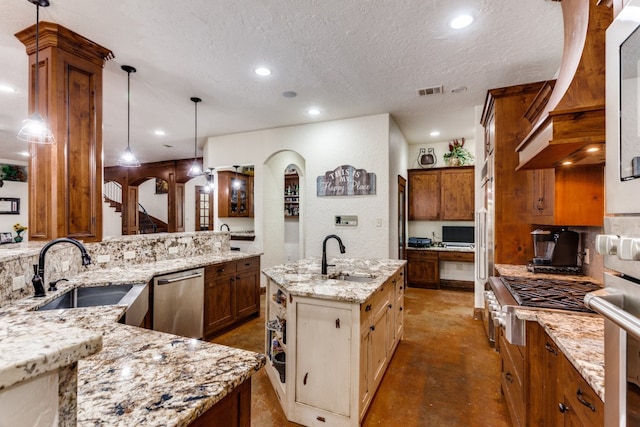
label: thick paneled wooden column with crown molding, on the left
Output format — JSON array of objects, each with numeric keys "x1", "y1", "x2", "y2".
[{"x1": 15, "y1": 22, "x2": 113, "y2": 242}]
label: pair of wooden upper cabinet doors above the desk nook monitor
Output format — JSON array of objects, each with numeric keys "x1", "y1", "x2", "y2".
[{"x1": 409, "y1": 167, "x2": 475, "y2": 221}]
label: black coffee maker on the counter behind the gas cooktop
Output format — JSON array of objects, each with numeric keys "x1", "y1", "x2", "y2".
[{"x1": 531, "y1": 229, "x2": 580, "y2": 267}]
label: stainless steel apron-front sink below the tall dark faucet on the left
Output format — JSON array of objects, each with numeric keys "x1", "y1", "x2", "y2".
[{"x1": 35, "y1": 284, "x2": 149, "y2": 326}]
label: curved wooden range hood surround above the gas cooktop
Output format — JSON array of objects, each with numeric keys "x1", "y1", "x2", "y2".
[{"x1": 516, "y1": 0, "x2": 613, "y2": 170}]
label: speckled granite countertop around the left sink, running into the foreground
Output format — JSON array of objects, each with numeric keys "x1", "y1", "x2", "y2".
[{"x1": 0, "y1": 252, "x2": 266, "y2": 426}]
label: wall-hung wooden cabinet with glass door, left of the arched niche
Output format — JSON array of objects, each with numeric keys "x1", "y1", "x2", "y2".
[{"x1": 218, "y1": 171, "x2": 253, "y2": 218}]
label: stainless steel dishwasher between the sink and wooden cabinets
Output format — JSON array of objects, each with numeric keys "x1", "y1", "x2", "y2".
[{"x1": 153, "y1": 268, "x2": 204, "y2": 338}]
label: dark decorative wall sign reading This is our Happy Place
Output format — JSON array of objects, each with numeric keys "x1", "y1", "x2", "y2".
[{"x1": 316, "y1": 165, "x2": 376, "y2": 197}]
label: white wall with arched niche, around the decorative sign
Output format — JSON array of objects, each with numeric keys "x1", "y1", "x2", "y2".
[{"x1": 203, "y1": 114, "x2": 406, "y2": 266}]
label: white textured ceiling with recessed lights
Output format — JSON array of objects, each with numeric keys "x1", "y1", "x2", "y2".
[{"x1": 0, "y1": 0, "x2": 563, "y2": 166}]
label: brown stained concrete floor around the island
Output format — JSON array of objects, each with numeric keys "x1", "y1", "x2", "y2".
[{"x1": 213, "y1": 288, "x2": 511, "y2": 427}]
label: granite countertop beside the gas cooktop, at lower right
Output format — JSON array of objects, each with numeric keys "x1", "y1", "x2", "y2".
[{"x1": 515, "y1": 308, "x2": 605, "y2": 402}]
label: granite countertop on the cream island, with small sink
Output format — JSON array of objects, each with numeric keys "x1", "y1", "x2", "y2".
[{"x1": 262, "y1": 258, "x2": 406, "y2": 304}]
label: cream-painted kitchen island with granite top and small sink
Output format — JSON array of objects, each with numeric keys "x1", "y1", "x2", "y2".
[{"x1": 263, "y1": 259, "x2": 406, "y2": 427}]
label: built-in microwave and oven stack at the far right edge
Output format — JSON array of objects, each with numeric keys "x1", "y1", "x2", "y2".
[{"x1": 585, "y1": 5, "x2": 640, "y2": 426}]
